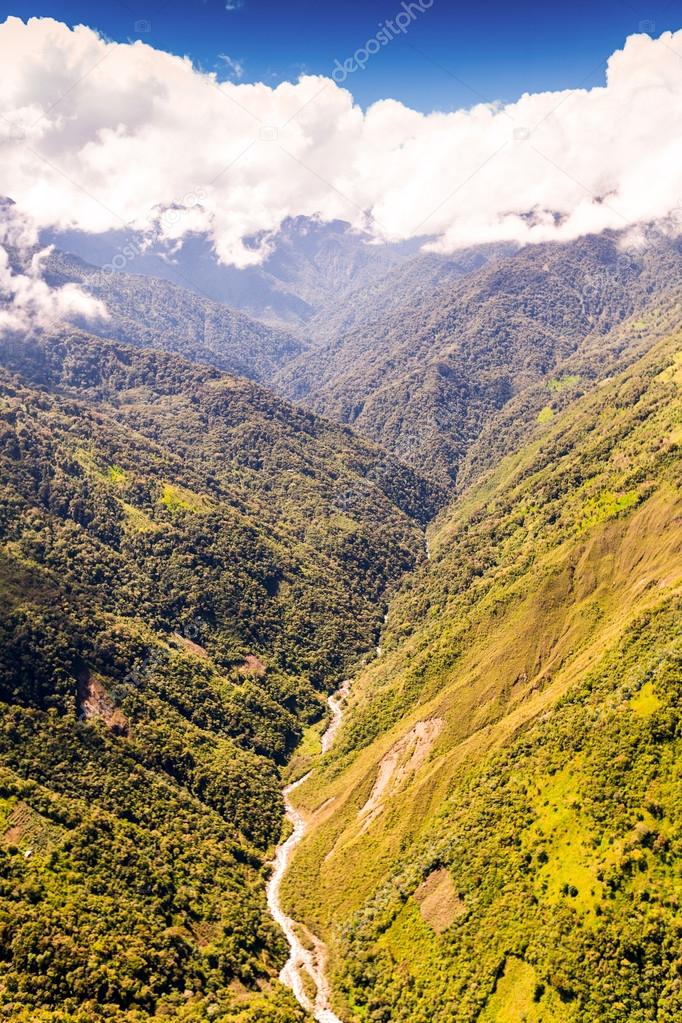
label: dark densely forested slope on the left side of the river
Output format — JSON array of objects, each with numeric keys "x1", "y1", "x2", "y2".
[{"x1": 0, "y1": 329, "x2": 435, "y2": 1023}]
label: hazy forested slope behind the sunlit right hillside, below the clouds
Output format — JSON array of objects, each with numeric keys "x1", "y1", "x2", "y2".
[{"x1": 274, "y1": 232, "x2": 682, "y2": 486}]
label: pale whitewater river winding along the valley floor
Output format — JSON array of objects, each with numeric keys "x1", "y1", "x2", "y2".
[{"x1": 267, "y1": 681, "x2": 349, "y2": 1023}]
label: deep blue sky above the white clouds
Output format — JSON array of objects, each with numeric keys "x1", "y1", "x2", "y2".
[{"x1": 3, "y1": 0, "x2": 682, "y2": 112}]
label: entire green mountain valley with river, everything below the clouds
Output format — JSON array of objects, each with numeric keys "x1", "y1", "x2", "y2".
[{"x1": 0, "y1": 215, "x2": 682, "y2": 1023}]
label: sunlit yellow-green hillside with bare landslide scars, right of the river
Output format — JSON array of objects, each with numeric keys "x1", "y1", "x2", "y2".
[{"x1": 285, "y1": 330, "x2": 682, "y2": 1023}]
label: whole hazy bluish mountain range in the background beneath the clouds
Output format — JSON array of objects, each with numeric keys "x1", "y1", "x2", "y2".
[{"x1": 49, "y1": 220, "x2": 682, "y2": 490}]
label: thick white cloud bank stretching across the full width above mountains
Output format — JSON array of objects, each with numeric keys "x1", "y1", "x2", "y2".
[{"x1": 0, "y1": 18, "x2": 682, "y2": 266}]
